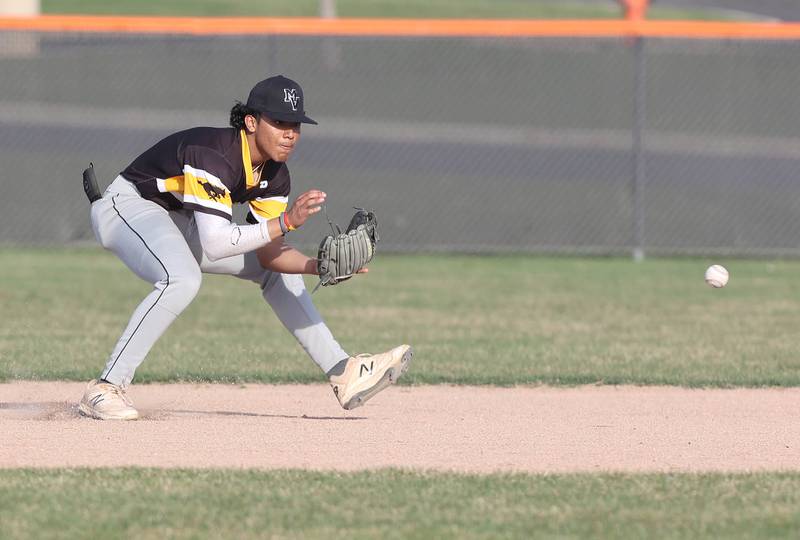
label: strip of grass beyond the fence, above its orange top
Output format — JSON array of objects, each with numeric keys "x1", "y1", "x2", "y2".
[{"x1": 42, "y1": 0, "x2": 764, "y2": 19}]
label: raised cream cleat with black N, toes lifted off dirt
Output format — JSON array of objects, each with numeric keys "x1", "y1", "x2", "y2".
[{"x1": 330, "y1": 345, "x2": 414, "y2": 410}]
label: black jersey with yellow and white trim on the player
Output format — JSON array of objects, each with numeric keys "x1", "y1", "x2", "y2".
[{"x1": 120, "y1": 127, "x2": 291, "y2": 223}]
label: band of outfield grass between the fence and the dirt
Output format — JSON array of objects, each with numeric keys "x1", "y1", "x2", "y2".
[{"x1": 0, "y1": 248, "x2": 800, "y2": 387}]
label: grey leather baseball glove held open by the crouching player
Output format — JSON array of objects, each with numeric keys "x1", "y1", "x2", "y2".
[{"x1": 314, "y1": 208, "x2": 380, "y2": 290}]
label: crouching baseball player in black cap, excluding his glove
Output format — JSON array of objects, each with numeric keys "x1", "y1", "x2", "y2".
[{"x1": 79, "y1": 76, "x2": 412, "y2": 420}]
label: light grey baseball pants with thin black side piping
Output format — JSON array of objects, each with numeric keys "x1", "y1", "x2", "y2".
[{"x1": 91, "y1": 176, "x2": 349, "y2": 387}]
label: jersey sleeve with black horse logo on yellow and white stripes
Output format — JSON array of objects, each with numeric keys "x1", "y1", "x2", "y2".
[{"x1": 183, "y1": 146, "x2": 234, "y2": 220}]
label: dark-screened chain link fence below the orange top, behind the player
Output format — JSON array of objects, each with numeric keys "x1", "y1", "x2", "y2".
[{"x1": 0, "y1": 32, "x2": 800, "y2": 256}]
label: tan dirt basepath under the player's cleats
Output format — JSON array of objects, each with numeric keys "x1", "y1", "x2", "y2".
[{"x1": 0, "y1": 382, "x2": 800, "y2": 472}]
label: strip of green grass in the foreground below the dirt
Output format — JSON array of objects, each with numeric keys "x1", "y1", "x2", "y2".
[{"x1": 0, "y1": 469, "x2": 800, "y2": 539}]
